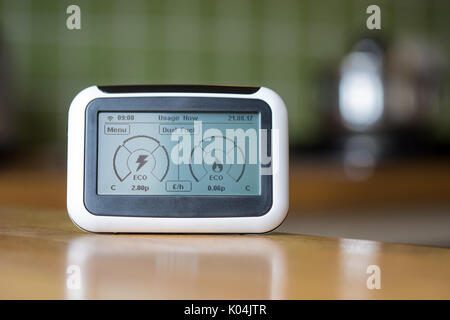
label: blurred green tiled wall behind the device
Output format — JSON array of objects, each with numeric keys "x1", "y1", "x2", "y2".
[{"x1": 0, "y1": 0, "x2": 450, "y2": 148}]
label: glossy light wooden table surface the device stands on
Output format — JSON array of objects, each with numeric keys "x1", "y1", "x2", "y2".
[{"x1": 0, "y1": 207, "x2": 450, "y2": 299}]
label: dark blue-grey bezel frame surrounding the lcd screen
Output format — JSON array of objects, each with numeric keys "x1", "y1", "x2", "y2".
[{"x1": 84, "y1": 97, "x2": 273, "y2": 218}]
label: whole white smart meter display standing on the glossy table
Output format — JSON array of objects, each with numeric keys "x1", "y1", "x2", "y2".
[{"x1": 67, "y1": 86, "x2": 288, "y2": 233}]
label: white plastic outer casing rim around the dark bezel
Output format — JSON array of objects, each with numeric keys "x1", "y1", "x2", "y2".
[{"x1": 67, "y1": 86, "x2": 289, "y2": 233}]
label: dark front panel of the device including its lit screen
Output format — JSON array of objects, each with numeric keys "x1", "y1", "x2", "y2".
[{"x1": 84, "y1": 97, "x2": 272, "y2": 217}]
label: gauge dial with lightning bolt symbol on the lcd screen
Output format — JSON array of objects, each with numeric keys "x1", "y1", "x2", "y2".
[{"x1": 113, "y1": 136, "x2": 169, "y2": 182}]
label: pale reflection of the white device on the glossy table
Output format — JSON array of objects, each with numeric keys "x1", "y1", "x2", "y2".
[{"x1": 65, "y1": 235, "x2": 286, "y2": 299}]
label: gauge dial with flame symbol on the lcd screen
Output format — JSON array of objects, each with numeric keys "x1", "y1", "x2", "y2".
[{"x1": 189, "y1": 136, "x2": 245, "y2": 182}]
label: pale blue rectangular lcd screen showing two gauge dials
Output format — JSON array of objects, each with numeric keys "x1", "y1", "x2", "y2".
[{"x1": 97, "y1": 112, "x2": 260, "y2": 196}]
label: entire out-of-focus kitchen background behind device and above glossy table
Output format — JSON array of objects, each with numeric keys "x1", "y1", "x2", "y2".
[{"x1": 0, "y1": 0, "x2": 450, "y2": 246}]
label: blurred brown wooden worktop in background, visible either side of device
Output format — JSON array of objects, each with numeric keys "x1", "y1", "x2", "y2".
[{"x1": 0, "y1": 155, "x2": 450, "y2": 215}]
